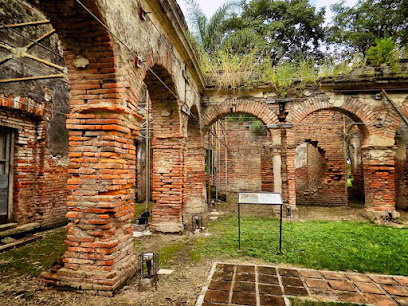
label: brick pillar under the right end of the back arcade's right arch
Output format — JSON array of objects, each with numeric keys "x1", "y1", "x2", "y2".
[{"x1": 362, "y1": 146, "x2": 399, "y2": 218}]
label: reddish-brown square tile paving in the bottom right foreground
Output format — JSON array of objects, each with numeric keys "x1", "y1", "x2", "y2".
[{"x1": 196, "y1": 263, "x2": 408, "y2": 306}]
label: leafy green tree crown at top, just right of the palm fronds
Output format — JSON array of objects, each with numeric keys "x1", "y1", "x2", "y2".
[{"x1": 225, "y1": 0, "x2": 325, "y2": 65}]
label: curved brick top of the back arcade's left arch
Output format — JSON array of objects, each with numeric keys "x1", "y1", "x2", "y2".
[{"x1": 202, "y1": 99, "x2": 279, "y2": 127}]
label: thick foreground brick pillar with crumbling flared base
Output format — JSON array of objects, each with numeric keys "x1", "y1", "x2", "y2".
[{"x1": 45, "y1": 110, "x2": 137, "y2": 295}]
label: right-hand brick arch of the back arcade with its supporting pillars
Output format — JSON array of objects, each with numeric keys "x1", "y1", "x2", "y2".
[{"x1": 286, "y1": 96, "x2": 400, "y2": 217}]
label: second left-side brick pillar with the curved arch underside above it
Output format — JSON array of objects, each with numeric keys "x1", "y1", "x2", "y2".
[{"x1": 144, "y1": 65, "x2": 185, "y2": 233}]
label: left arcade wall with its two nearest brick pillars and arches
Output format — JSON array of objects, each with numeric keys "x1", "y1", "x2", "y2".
[{"x1": 30, "y1": 0, "x2": 206, "y2": 293}]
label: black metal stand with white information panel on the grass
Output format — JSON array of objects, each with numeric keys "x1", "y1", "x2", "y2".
[{"x1": 238, "y1": 192, "x2": 283, "y2": 254}]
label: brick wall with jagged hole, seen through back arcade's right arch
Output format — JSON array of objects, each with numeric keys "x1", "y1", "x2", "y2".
[{"x1": 295, "y1": 110, "x2": 347, "y2": 205}]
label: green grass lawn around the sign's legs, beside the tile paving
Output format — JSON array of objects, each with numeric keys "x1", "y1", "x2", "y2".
[{"x1": 191, "y1": 216, "x2": 408, "y2": 275}]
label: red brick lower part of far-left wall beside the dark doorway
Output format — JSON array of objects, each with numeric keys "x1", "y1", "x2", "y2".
[{"x1": 0, "y1": 96, "x2": 68, "y2": 226}]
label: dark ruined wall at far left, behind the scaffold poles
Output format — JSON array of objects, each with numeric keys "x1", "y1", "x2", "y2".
[{"x1": 0, "y1": 1, "x2": 69, "y2": 227}]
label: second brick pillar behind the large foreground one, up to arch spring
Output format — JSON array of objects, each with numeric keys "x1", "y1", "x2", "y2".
[{"x1": 151, "y1": 137, "x2": 185, "y2": 233}]
